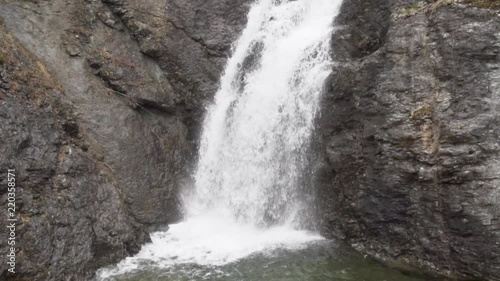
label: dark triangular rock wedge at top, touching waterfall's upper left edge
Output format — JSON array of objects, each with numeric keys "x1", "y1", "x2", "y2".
[{"x1": 99, "y1": 0, "x2": 251, "y2": 139}]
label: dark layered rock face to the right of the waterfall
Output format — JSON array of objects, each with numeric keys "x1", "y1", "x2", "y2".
[{"x1": 317, "y1": 0, "x2": 500, "y2": 280}]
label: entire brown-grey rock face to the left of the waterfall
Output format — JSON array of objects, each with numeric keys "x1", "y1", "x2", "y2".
[{"x1": 0, "y1": 0, "x2": 248, "y2": 281}]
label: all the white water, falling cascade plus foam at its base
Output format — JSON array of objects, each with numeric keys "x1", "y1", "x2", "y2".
[{"x1": 100, "y1": 0, "x2": 341, "y2": 278}]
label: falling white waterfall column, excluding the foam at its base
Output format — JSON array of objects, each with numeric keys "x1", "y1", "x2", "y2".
[{"x1": 189, "y1": 0, "x2": 340, "y2": 226}]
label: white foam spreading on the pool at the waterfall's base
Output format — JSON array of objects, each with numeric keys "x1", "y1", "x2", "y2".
[{"x1": 100, "y1": 213, "x2": 322, "y2": 279}]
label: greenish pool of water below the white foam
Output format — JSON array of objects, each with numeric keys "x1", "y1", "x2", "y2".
[{"x1": 97, "y1": 240, "x2": 430, "y2": 281}]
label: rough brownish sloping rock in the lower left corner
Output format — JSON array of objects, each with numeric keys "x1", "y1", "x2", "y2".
[{"x1": 0, "y1": 26, "x2": 149, "y2": 281}]
